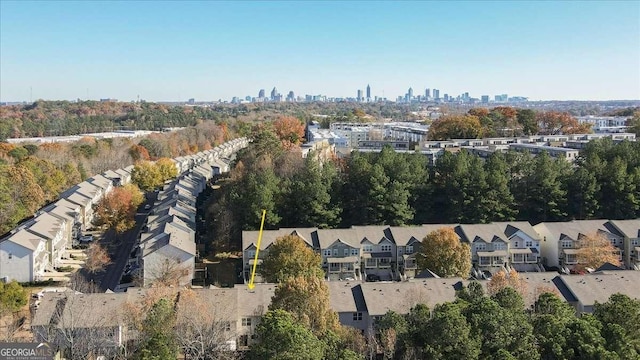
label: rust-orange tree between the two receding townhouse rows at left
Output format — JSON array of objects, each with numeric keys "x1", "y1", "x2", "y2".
[{"x1": 94, "y1": 184, "x2": 143, "y2": 233}]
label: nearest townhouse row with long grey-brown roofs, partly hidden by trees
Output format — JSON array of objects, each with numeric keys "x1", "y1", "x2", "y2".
[{"x1": 31, "y1": 270, "x2": 640, "y2": 354}]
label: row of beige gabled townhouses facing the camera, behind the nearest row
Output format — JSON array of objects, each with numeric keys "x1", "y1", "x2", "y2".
[{"x1": 242, "y1": 219, "x2": 640, "y2": 282}]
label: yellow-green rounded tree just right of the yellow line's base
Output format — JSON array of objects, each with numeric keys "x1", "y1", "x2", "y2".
[{"x1": 260, "y1": 235, "x2": 324, "y2": 283}]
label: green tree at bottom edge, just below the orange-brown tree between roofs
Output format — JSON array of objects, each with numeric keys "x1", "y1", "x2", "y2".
[{"x1": 249, "y1": 310, "x2": 324, "y2": 360}]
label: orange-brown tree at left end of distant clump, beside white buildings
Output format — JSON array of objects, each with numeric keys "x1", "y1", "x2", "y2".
[{"x1": 429, "y1": 115, "x2": 482, "y2": 140}]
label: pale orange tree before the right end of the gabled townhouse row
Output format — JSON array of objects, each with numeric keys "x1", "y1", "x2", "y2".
[{"x1": 576, "y1": 234, "x2": 620, "y2": 270}]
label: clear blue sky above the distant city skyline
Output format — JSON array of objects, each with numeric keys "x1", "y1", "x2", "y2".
[{"x1": 0, "y1": 0, "x2": 640, "y2": 101}]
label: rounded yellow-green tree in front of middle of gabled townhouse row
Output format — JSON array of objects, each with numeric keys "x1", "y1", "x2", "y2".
[{"x1": 416, "y1": 228, "x2": 471, "y2": 278}]
